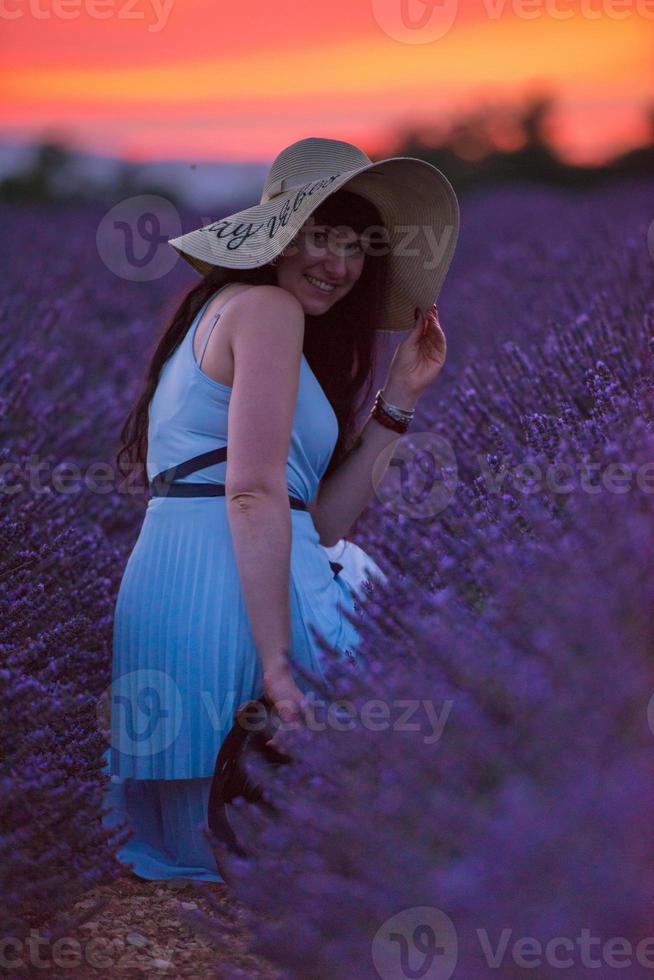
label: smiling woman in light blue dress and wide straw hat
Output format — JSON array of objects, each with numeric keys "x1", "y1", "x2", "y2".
[{"x1": 105, "y1": 138, "x2": 458, "y2": 881}]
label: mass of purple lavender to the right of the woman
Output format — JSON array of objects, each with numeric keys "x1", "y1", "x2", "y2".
[{"x1": 200, "y1": 178, "x2": 654, "y2": 980}]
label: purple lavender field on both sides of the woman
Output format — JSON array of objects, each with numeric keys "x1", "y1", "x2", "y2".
[{"x1": 0, "y1": 182, "x2": 654, "y2": 980}]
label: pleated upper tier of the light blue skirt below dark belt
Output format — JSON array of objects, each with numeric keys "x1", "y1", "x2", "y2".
[{"x1": 110, "y1": 497, "x2": 360, "y2": 780}]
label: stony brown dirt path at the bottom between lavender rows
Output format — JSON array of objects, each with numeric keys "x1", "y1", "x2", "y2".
[{"x1": 35, "y1": 870, "x2": 279, "y2": 980}]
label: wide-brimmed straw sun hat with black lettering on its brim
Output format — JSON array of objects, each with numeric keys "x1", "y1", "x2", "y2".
[{"x1": 168, "y1": 137, "x2": 459, "y2": 331}]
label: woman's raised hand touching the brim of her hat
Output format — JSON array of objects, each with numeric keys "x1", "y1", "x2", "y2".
[{"x1": 384, "y1": 303, "x2": 447, "y2": 408}]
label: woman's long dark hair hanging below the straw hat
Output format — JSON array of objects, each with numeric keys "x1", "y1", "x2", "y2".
[{"x1": 116, "y1": 189, "x2": 389, "y2": 498}]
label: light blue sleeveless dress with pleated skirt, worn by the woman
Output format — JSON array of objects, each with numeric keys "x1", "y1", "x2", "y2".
[{"x1": 103, "y1": 284, "x2": 383, "y2": 881}]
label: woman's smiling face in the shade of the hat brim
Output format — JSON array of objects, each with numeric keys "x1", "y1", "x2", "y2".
[{"x1": 275, "y1": 215, "x2": 366, "y2": 316}]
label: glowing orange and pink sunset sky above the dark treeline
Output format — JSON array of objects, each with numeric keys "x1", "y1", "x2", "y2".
[{"x1": 0, "y1": 0, "x2": 654, "y2": 161}]
